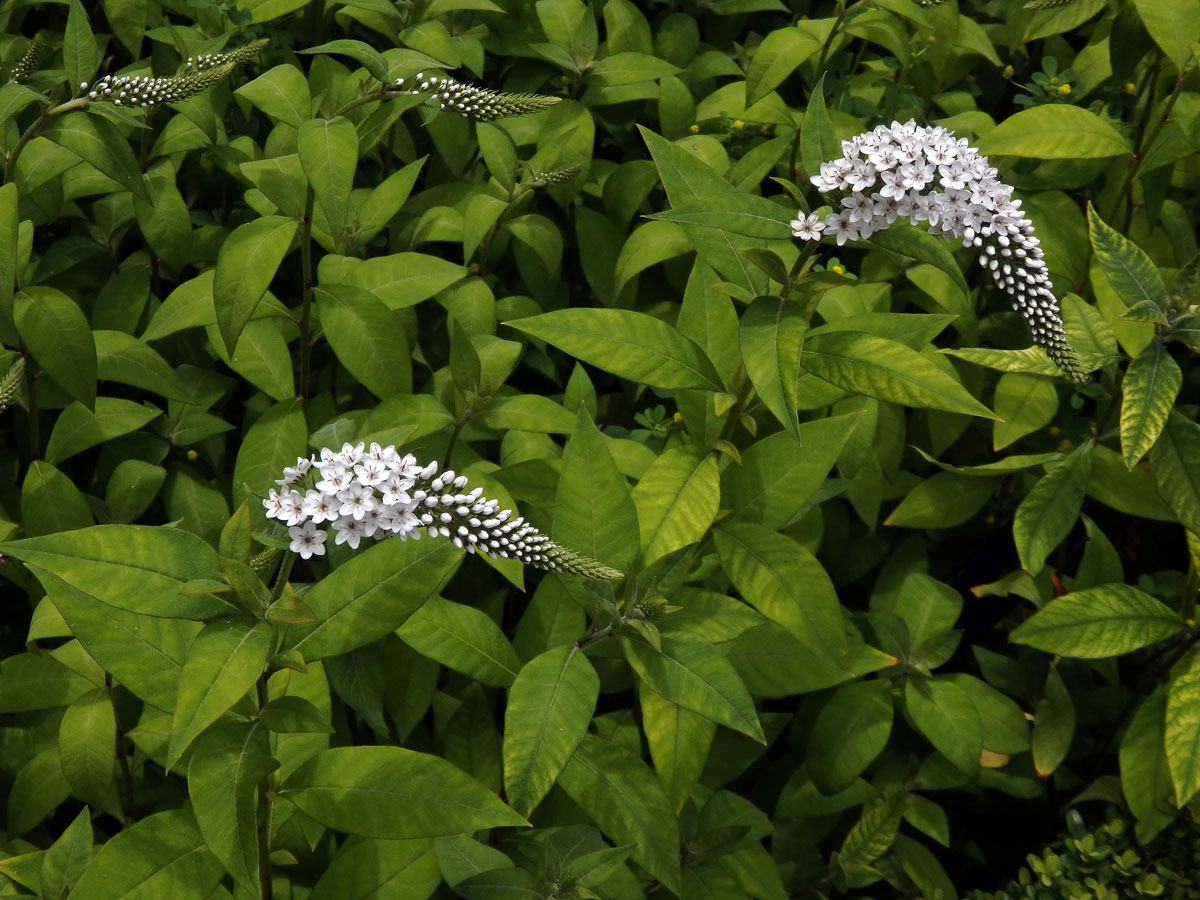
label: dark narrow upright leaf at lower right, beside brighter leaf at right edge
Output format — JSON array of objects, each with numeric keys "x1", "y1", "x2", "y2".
[{"x1": 1118, "y1": 685, "x2": 1175, "y2": 844}]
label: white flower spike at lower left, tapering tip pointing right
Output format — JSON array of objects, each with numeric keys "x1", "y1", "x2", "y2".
[{"x1": 263, "y1": 443, "x2": 622, "y2": 580}]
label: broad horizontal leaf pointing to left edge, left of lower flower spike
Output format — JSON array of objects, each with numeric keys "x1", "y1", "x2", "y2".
[{"x1": 0, "y1": 526, "x2": 229, "y2": 619}]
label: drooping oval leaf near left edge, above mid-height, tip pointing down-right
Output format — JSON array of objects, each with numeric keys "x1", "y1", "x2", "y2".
[{"x1": 13, "y1": 286, "x2": 96, "y2": 407}]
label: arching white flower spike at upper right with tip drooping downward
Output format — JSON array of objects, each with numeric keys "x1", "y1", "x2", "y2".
[{"x1": 791, "y1": 119, "x2": 1087, "y2": 382}]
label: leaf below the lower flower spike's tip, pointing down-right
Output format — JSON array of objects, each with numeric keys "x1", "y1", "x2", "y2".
[{"x1": 622, "y1": 634, "x2": 767, "y2": 744}]
